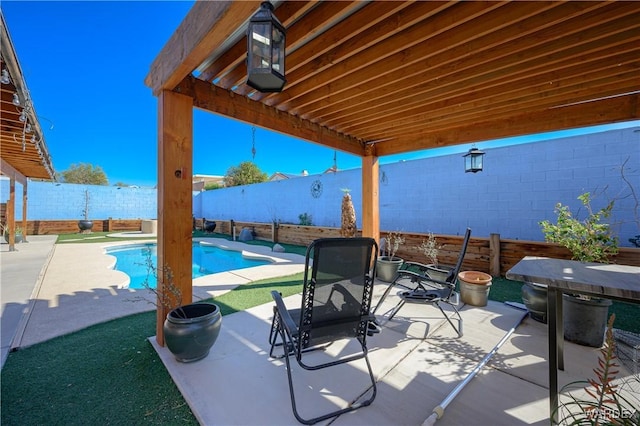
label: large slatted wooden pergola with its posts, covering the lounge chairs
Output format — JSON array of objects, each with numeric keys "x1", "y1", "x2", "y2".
[{"x1": 145, "y1": 1, "x2": 640, "y2": 344}]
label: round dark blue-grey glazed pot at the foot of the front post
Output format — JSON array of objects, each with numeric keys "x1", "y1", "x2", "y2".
[{"x1": 163, "y1": 303, "x2": 222, "y2": 362}]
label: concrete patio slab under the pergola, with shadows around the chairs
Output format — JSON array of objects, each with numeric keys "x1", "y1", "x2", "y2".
[{"x1": 151, "y1": 284, "x2": 628, "y2": 425}]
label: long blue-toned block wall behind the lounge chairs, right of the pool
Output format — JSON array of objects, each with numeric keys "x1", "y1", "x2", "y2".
[{"x1": 194, "y1": 127, "x2": 640, "y2": 246}]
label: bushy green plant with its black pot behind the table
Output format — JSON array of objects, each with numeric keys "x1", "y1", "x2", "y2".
[{"x1": 523, "y1": 192, "x2": 618, "y2": 347}]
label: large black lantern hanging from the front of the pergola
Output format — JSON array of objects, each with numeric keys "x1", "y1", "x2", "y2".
[{"x1": 247, "y1": 1, "x2": 287, "y2": 92}]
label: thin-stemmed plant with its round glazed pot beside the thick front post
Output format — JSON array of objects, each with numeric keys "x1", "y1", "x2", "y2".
[{"x1": 143, "y1": 251, "x2": 222, "y2": 363}]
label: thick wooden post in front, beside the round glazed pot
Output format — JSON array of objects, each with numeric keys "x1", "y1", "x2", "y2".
[{"x1": 156, "y1": 90, "x2": 193, "y2": 346}]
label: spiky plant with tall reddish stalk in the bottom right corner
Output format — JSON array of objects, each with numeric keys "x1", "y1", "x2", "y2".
[{"x1": 552, "y1": 314, "x2": 640, "y2": 425}]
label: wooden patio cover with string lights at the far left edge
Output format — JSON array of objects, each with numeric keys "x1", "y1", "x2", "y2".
[{"x1": 0, "y1": 14, "x2": 56, "y2": 251}]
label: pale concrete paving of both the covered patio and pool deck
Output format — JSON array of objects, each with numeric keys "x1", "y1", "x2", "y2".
[{"x1": 2, "y1": 236, "x2": 640, "y2": 425}]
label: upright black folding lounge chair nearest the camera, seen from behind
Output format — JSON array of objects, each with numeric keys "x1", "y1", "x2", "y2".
[{"x1": 269, "y1": 238, "x2": 378, "y2": 424}]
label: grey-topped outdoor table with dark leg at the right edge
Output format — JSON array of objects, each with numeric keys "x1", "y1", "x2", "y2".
[{"x1": 506, "y1": 256, "x2": 640, "y2": 420}]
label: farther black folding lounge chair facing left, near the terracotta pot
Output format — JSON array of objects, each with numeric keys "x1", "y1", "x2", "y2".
[{"x1": 372, "y1": 228, "x2": 471, "y2": 337}]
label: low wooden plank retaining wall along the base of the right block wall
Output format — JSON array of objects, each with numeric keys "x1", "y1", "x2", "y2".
[{"x1": 208, "y1": 219, "x2": 640, "y2": 276}]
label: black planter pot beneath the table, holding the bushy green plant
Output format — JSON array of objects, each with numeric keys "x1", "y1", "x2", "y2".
[{"x1": 562, "y1": 294, "x2": 611, "y2": 348}]
